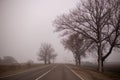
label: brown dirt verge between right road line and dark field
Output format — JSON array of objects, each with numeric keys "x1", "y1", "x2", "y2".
[{"x1": 66, "y1": 66, "x2": 112, "y2": 80}]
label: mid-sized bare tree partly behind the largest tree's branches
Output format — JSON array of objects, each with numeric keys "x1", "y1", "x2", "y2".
[{"x1": 62, "y1": 33, "x2": 91, "y2": 65}]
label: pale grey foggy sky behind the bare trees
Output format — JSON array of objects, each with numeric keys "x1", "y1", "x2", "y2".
[{"x1": 0, "y1": 0, "x2": 120, "y2": 62}]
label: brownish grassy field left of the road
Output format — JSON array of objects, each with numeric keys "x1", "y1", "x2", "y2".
[{"x1": 0, "y1": 64, "x2": 45, "y2": 77}]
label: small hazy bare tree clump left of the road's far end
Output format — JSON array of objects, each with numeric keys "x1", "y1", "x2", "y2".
[{"x1": 38, "y1": 43, "x2": 57, "y2": 64}]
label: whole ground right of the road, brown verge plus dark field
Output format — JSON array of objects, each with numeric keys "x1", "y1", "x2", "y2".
[{"x1": 69, "y1": 64, "x2": 120, "y2": 80}]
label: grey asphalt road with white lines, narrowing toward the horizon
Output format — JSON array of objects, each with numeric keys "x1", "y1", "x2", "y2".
[{"x1": 0, "y1": 64, "x2": 80, "y2": 80}]
